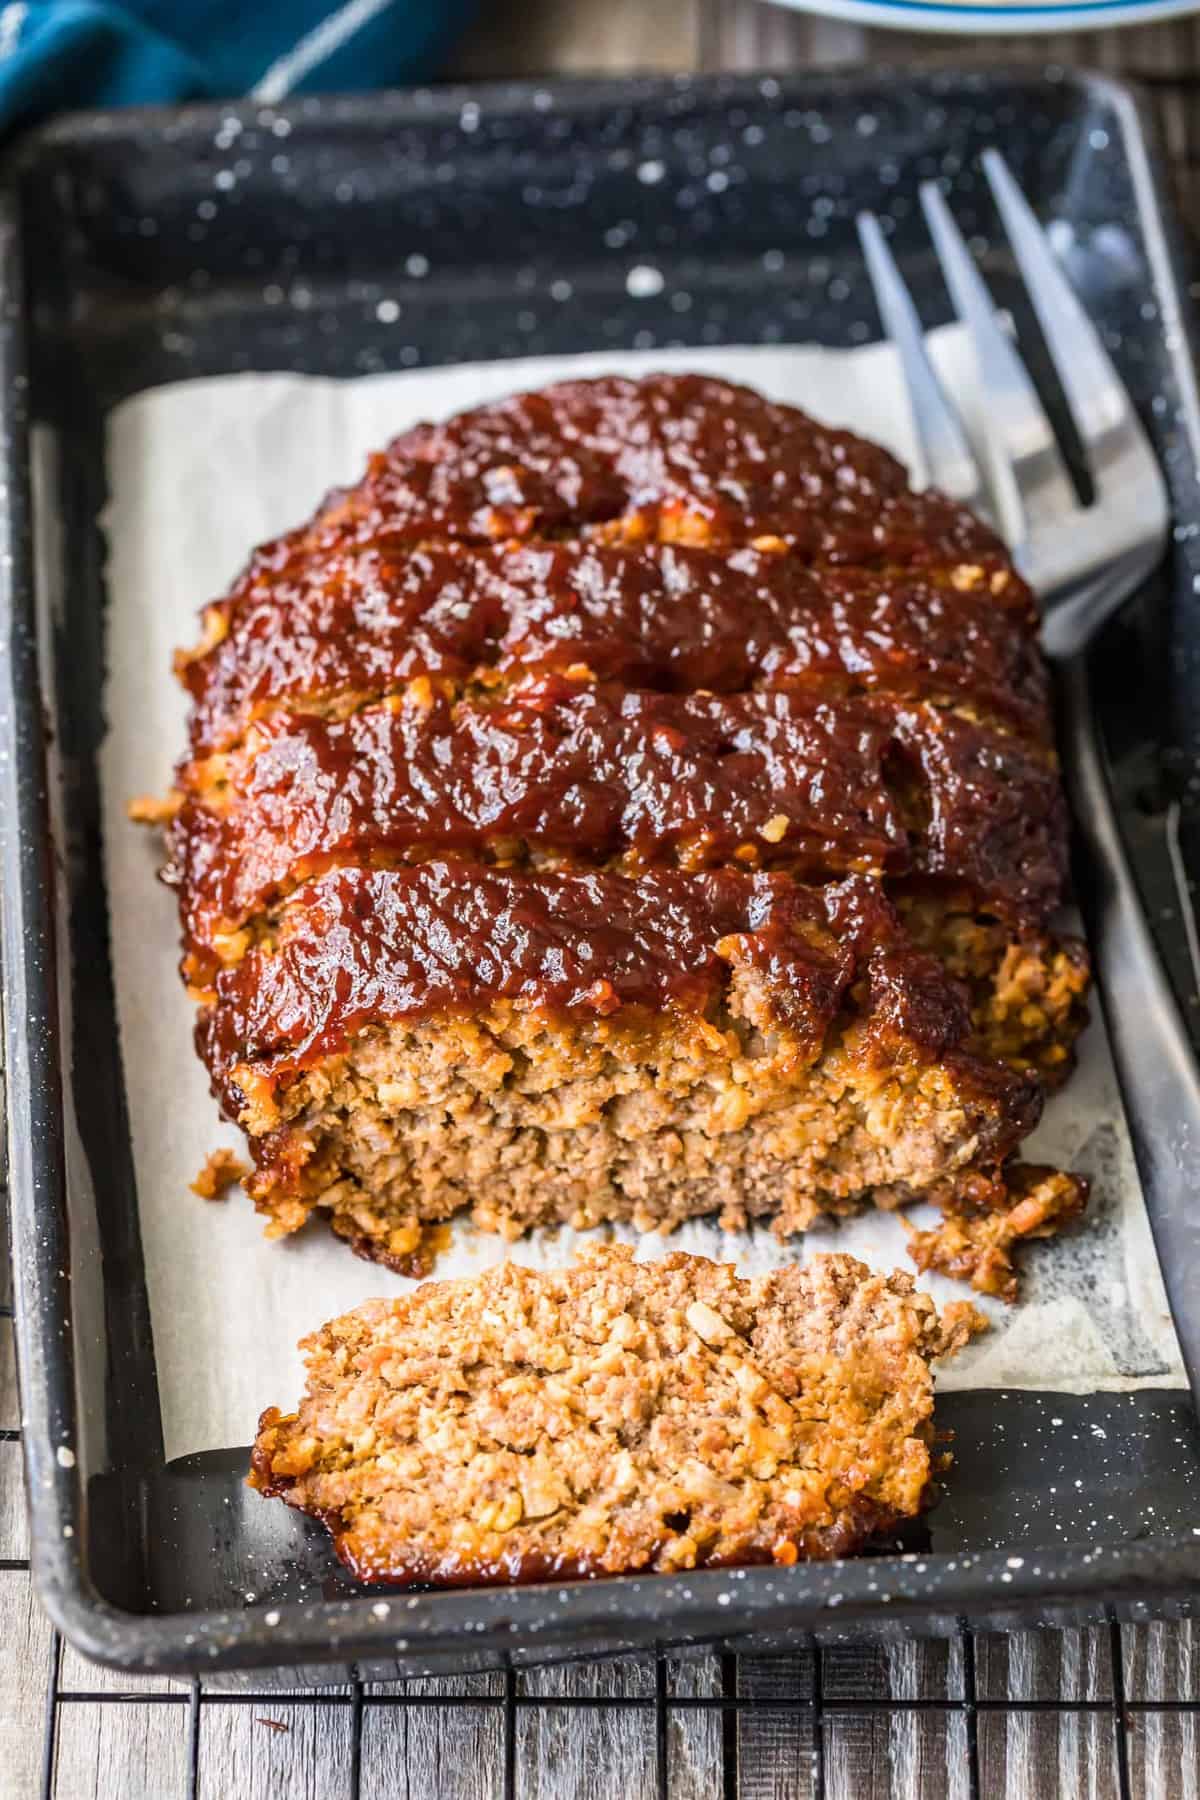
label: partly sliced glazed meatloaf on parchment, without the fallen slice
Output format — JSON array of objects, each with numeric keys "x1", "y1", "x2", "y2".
[{"x1": 154, "y1": 376, "x2": 1087, "y2": 1289}]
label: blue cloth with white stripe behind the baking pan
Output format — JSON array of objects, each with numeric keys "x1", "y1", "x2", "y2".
[{"x1": 0, "y1": 0, "x2": 475, "y2": 137}]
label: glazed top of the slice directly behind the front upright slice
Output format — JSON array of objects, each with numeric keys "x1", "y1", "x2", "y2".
[{"x1": 169, "y1": 677, "x2": 1065, "y2": 968}]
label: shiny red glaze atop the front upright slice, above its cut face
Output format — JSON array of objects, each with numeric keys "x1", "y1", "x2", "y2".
[{"x1": 201, "y1": 860, "x2": 881, "y2": 1078}]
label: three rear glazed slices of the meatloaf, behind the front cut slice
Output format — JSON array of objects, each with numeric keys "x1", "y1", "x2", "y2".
[{"x1": 169, "y1": 376, "x2": 1065, "y2": 1015}]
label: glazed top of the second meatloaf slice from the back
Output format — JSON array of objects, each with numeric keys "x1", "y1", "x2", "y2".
[{"x1": 178, "y1": 531, "x2": 1049, "y2": 756}]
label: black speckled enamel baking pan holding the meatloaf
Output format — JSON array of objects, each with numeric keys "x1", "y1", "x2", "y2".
[{"x1": 0, "y1": 70, "x2": 1200, "y2": 1681}]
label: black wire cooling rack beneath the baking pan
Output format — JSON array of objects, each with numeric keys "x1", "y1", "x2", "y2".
[{"x1": 16, "y1": 1624, "x2": 1200, "y2": 1800}]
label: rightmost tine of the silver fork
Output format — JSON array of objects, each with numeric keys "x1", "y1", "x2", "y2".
[{"x1": 982, "y1": 149, "x2": 1133, "y2": 448}]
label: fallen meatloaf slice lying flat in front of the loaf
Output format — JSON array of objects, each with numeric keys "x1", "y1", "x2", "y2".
[{"x1": 250, "y1": 1247, "x2": 979, "y2": 1584}]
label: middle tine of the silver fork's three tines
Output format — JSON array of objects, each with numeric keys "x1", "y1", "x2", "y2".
[{"x1": 921, "y1": 182, "x2": 1078, "y2": 542}]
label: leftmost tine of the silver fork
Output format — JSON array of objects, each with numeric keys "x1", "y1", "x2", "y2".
[{"x1": 858, "y1": 212, "x2": 984, "y2": 511}]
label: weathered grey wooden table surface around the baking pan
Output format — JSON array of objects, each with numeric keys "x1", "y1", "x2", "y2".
[{"x1": 0, "y1": 0, "x2": 1200, "y2": 1800}]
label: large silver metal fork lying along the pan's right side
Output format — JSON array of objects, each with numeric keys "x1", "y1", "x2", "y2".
[{"x1": 858, "y1": 149, "x2": 1200, "y2": 1406}]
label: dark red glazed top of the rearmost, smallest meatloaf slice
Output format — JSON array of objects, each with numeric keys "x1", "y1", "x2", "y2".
[{"x1": 318, "y1": 374, "x2": 997, "y2": 565}]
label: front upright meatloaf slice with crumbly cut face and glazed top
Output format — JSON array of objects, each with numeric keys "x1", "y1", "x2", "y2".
[{"x1": 198, "y1": 862, "x2": 1042, "y2": 1269}]
